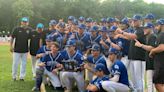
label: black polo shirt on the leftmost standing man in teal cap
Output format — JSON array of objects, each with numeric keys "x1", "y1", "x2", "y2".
[{"x1": 11, "y1": 27, "x2": 32, "y2": 53}]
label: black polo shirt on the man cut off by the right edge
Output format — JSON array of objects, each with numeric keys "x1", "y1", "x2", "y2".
[{"x1": 154, "y1": 32, "x2": 164, "y2": 69}]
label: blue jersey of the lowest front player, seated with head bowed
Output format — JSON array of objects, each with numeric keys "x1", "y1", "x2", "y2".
[{"x1": 88, "y1": 76, "x2": 109, "y2": 92}]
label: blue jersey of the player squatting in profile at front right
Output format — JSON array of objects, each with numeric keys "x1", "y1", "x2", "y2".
[{"x1": 111, "y1": 60, "x2": 129, "y2": 86}]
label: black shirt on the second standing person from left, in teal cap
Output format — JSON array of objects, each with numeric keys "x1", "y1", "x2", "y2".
[{"x1": 29, "y1": 30, "x2": 43, "y2": 56}]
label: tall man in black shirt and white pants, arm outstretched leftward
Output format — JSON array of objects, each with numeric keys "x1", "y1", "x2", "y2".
[{"x1": 117, "y1": 15, "x2": 146, "y2": 92}]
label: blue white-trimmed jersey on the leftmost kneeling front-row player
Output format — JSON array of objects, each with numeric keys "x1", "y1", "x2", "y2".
[{"x1": 41, "y1": 52, "x2": 63, "y2": 72}]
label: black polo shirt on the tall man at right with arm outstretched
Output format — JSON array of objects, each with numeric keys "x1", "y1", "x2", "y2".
[{"x1": 128, "y1": 27, "x2": 146, "y2": 61}]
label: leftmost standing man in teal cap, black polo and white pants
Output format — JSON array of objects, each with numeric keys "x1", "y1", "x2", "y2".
[{"x1": 10, "y1": 17, "x2": 32, "y2": 81}]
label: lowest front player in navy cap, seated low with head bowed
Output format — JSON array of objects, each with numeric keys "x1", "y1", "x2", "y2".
[{"x1": 86, "y1": 63, "x2": 109, "y2": 92}]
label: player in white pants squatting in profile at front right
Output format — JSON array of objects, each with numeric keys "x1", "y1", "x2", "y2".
[{"x1": 102, "y1": 48, "x2": 129, "y2": 92}]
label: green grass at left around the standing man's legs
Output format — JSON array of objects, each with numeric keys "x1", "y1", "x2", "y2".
[{"x1": 0, "y1": 45, "x2": 54, "y2": 92}]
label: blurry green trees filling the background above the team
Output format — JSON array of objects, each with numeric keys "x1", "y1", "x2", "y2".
[{"x1": 0, "y1": 0, "x2": 164, "y2": 31}]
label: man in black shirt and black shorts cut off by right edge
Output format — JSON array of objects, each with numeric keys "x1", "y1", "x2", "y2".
[{"x1": 149, "y1": 19, "x2": 164, "y2": 92}]
